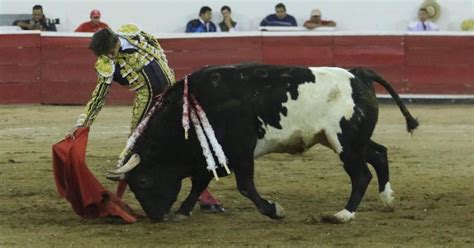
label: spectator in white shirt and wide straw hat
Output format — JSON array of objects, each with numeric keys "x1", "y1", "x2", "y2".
[{"x1": 408, "y1": 0, "x2": 440, "y2": 31}]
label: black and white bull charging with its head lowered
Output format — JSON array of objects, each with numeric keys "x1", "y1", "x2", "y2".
[{"x1": 127, "y1": 64, "x2": 418, "y2": 223}]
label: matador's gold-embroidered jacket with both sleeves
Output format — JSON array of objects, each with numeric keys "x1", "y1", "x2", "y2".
[{"x1": 76, "y1": 24, "x2": 175, "y2": 130}]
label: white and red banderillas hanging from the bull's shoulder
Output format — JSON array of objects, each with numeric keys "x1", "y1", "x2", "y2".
[{"x1": 182, "y1": 76, "x2": 230, "y2": 181}]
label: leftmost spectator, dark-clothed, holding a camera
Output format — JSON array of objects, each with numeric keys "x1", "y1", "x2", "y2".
[{"x1": 13, "y1": 5, "x2": 59, "y2": 31}]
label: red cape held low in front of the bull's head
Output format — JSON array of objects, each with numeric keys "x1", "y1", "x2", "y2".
[{"x1": 53, "y1": 127, "x2": 136, "y2": 223}]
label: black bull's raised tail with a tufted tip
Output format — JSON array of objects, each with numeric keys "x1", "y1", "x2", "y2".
[{"x1": 350, "y1": 68, "x2": 419, "y2": 133}]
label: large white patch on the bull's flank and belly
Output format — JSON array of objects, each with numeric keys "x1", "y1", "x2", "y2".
[{"x1": 254, "y1": 67, "x2": 354, "y2": 157}]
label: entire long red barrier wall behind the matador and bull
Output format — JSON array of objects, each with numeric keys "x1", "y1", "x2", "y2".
[{"x1": 0, "y1": 34, "x2": 474, "y2": 104}]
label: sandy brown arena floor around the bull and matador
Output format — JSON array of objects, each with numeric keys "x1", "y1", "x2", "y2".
[{"x1": 0, "y1": 104, "x2": 474, "y2": 247}]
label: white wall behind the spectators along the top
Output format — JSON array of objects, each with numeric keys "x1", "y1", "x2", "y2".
[{"x1": 0, "y1": 0, "x2": 474, "y2": 33}]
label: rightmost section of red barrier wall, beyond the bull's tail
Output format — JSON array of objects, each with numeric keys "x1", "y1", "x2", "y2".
[{"x1": 405, "y1": 36, "x2": 474, "y2": 94}]
